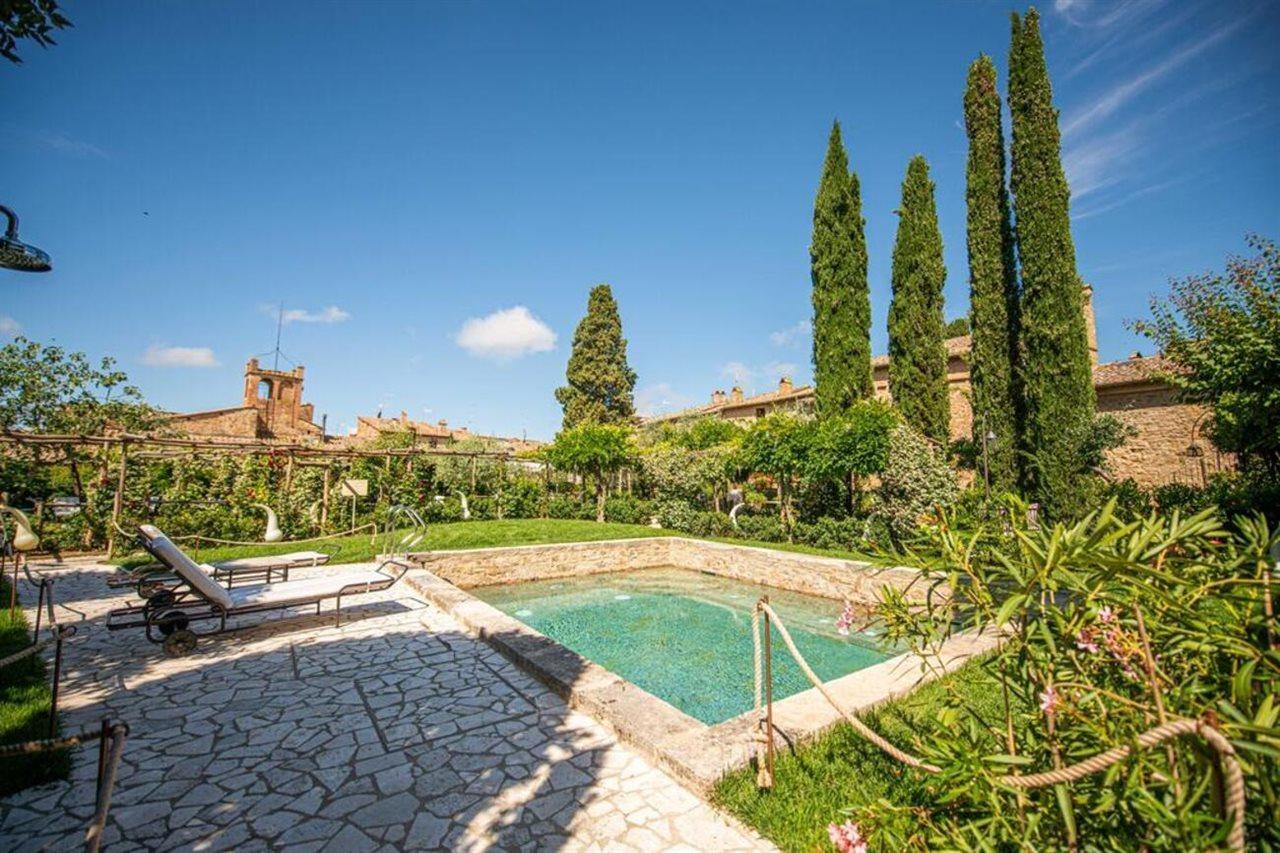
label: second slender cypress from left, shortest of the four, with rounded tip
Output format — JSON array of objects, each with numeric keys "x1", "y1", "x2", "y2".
[{"x1": 888, "y1": 155, "x2": 951, "y2": 443}]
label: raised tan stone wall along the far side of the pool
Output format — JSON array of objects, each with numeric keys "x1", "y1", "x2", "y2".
[{"x1": 408, "y1": 537, "x2": 948, "y2": 605}]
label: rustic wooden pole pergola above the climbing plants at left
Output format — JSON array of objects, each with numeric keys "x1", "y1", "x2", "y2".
[{"x1": 0, "y1": 432, "x2": 527, "y2": 558}]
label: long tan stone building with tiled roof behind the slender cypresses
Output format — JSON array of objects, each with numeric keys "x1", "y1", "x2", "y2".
[{"x1": 648, "y1": 287, "x2": 1235, "y2": 485}]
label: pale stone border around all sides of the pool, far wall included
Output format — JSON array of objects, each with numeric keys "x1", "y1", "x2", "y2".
[{"x1": 406, "y1": 537, "x2": 996, "y2": 795}]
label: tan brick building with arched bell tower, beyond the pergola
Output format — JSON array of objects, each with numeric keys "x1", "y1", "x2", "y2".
[{"x1": 164, "y1": 359, "x2": 323, "y2": 441}]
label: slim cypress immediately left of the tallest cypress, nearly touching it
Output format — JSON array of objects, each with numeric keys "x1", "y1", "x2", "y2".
[{"x1": 964, "y1": 55, "x2": 1021, "y2": 491}]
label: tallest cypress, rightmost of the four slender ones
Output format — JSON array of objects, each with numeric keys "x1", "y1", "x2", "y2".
[{"x1": 1009, "y1": 8, "x2": 1097, "y2": 512}]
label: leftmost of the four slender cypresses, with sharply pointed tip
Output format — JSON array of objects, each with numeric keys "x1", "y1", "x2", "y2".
[{"x1": 809, "y1": 120, "x2": 873, "y2": 414}]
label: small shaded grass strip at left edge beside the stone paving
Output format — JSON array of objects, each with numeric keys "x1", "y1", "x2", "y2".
[{"x1": 0, "y1": 579, "x2": 70, "y2": 797}]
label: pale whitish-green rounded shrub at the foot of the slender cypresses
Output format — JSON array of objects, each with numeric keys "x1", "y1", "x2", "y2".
[{"x1": 876, "y1": 424, "x2": 959, "y2": 539}]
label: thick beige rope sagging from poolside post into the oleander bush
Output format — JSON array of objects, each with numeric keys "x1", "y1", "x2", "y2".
[{"x1": 751, "y1": 598, "x2": 1245, "y2": 852}]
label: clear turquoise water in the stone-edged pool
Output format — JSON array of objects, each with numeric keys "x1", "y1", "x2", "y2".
[{"x1": 468, "y1": 569, "x2": 892, "y2": 725}]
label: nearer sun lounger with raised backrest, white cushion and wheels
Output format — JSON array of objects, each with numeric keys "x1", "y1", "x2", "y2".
[{"x1": 106, "y1": 525, "x2": 411, "y2": 656}]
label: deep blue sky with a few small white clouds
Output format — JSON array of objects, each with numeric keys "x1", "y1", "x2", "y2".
[{"x1": 0, "y1": 0, "x2": 1280, "y2": 438}]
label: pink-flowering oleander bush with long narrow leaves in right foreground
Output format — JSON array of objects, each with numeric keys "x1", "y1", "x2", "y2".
[{"x1": 852, "y1": 502, "x2": 1280, "y2": 850}]
